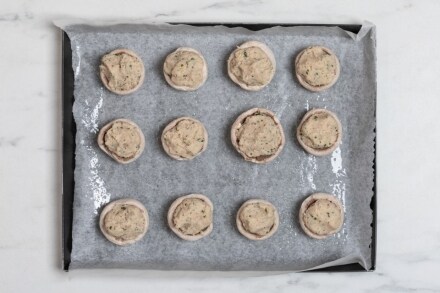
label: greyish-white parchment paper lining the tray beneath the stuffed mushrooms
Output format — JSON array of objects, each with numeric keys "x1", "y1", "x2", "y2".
[{"x1": 60, "y1": 24, "x2": 376, "y2": 271}]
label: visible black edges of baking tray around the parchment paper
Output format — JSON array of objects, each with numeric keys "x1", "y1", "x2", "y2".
[{"x1": 62, "y1": 23, "x2": 377, "y2": 272}]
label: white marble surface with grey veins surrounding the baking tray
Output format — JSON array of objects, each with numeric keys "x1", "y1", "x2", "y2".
[{"x1": 0, "y1": 0, "x2": 440, "y2": 293}]
